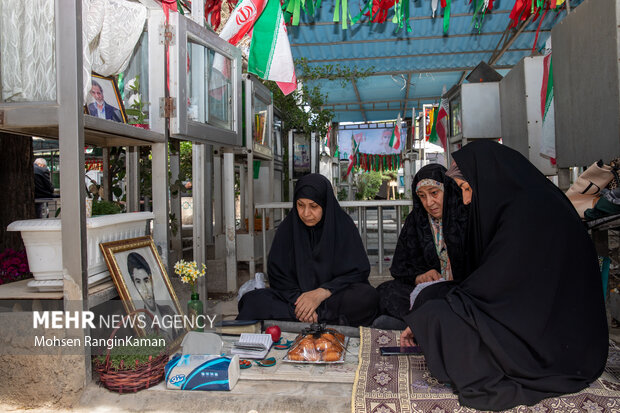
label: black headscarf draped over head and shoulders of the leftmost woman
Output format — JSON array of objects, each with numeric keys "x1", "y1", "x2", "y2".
[{"x1": 267, "y1": 174, "x2": 370, "y2": 303}]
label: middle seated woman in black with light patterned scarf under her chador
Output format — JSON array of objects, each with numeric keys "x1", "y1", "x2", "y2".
[{"x1": 373, "y1": 164, "x2": 467, "y2": 330}]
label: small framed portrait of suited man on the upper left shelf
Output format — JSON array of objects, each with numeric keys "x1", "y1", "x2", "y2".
[{"x1": 84, "y1": 73, "x2": 127, "y2": 123}]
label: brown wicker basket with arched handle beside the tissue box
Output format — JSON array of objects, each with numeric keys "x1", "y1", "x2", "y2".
[{"x1": 93, "y1": 309, "x2": 168, "y2": 394}]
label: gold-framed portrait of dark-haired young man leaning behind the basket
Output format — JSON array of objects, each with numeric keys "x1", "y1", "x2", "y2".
[{"x1": 99, "y1": 236, "x2": 187, "y2": 347}]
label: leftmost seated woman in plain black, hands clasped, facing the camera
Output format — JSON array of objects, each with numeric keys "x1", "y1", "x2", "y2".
[{"x1": 237, "y1": 174, "x2": 378, "y2": 326}]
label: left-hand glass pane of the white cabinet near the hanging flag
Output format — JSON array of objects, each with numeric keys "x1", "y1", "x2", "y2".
[{"x1": 187, "y1": 41, "x2": 209, "y2": 123}]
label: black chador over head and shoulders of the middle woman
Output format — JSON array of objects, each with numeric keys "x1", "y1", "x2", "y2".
[{"x1": 390, "y1": 164, "x2": 468, "y2": 285}]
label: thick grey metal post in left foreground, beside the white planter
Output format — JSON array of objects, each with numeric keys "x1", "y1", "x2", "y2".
[{"x1": 54, "y1": 0, "x2": 91, "y2": 386}]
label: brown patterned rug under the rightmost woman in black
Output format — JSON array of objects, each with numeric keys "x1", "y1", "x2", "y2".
[{"x1": 351, "y1": 328, "x2": 620, "y2": 413}]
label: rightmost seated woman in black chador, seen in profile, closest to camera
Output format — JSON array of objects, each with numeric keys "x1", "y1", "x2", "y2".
[{"x1": 401, "y1": 141, "x2": 608, "y2": 410}]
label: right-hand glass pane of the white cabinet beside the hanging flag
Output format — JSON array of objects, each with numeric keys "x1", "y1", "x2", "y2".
[{"x1": 208, "y1": 50, "x2": 233, "y2": 129}]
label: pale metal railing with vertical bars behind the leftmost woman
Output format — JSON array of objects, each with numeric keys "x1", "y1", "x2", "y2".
[{"x1": 256, "y1": 199, "x2": 412, "y2": 274}]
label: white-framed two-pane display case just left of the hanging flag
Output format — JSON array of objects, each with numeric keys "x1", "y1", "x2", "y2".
[{"x1": 170, "y1": 14, "x2": 242, "y2": 146}]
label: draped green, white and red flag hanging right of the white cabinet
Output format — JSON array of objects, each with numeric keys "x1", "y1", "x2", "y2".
[{"x1": 248, "y1": 0, "x2": 297, "y2": 95}]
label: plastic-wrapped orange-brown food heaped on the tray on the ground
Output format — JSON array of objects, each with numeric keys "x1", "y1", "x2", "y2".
[{"x1": 285, "y1": 324, "x2": 347, "y2": 363}]
